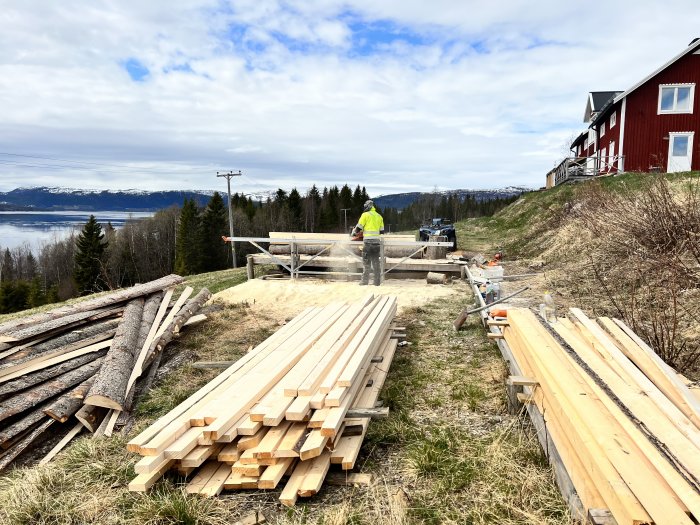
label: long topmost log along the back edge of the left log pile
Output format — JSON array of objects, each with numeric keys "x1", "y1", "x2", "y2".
[{"x1": 0, "y1": 274, "x2": 185, "y2": 334}]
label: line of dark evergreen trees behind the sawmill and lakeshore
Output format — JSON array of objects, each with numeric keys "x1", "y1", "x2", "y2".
[{"x1": 0, "y1": 184, "x2": 514, "y2": 313}]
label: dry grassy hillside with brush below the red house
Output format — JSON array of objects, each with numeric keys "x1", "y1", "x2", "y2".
[{"x1": 457, "y1": 172, "x2": 700, "y2": 377}]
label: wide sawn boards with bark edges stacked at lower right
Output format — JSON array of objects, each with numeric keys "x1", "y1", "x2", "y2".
[{"x1": 498, "y1": 308, "x2": 700, "y2": 525}]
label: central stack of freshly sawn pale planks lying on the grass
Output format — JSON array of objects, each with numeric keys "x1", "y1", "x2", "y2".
[{"x1": 128, "y1": 295, "x2": 397, "y2": 506}]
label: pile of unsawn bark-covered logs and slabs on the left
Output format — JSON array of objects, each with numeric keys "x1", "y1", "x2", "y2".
[{"x1": 0, "y1": 275, "x2": 211, "y2": 470}]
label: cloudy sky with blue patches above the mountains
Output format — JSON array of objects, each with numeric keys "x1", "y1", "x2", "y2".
[{"x1": 0, "y1": 0, "x2": 700, "y2": 195}]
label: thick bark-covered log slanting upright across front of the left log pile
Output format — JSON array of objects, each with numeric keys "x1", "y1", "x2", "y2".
[{"x1": 85, "y1": 298, "x2": 144, "y2": 410}]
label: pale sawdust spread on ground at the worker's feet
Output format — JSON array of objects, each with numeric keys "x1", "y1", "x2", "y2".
[{"x1": 214, "y1": 278, "x2": 466, "y2": 319}]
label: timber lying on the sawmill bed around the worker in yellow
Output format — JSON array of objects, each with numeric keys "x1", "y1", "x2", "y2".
[{"x1": 270, "y1": 232, "x2": 423, "y2": 259}]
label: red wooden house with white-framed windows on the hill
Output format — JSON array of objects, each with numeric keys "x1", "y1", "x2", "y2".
[{"x1": 547, "y1": 39, "x2": 700, "y2": 187}]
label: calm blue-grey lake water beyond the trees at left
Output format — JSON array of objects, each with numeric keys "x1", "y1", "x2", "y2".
[{"x1": 0, "y1": 211, "x2": 153, "y2": 252}]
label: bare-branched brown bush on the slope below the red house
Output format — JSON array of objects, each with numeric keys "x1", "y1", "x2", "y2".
[{"x1": 572, "y1": 175, "x2": 700, "y2": 371}]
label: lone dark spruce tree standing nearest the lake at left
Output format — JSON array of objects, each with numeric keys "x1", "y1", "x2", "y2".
[{"x1": 73, "y1": 215, "x2": 107, "y2": 295}]
